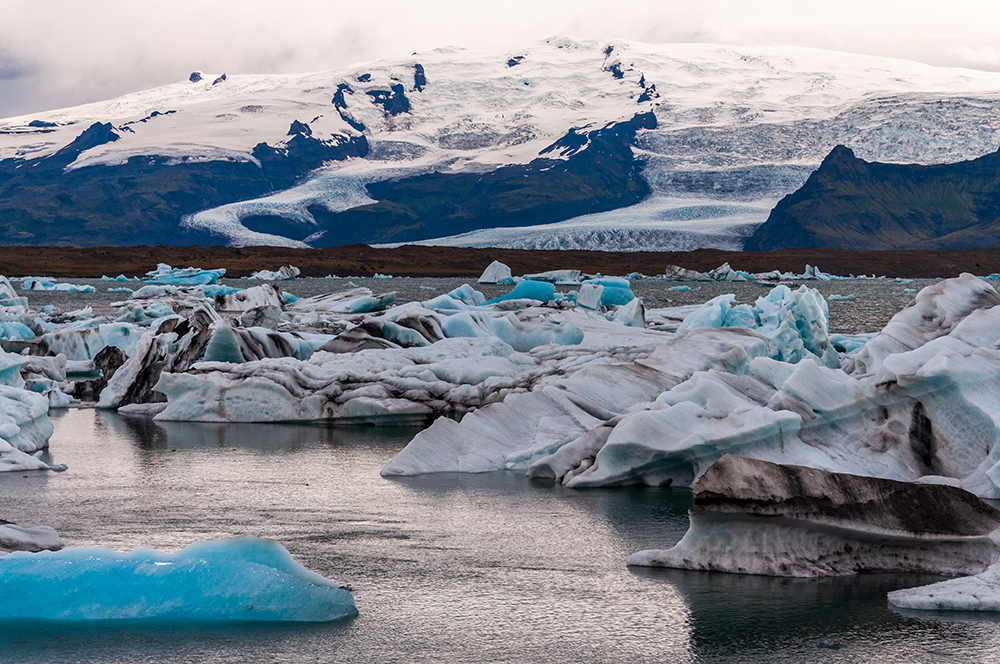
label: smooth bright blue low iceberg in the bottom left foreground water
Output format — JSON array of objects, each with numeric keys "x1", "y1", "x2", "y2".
[{"x1": 0, "y1": 537, "x2": 358, "y2": 622}]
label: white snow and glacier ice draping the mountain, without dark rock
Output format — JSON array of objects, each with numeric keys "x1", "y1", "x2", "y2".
[{"x1": 0, "y1": 37, "x2": 1000, "y2": 251}]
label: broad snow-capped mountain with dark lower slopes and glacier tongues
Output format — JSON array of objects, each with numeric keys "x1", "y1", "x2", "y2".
[{"x1": 0, "y1": 38, "x2": 1000, "y2": 250}]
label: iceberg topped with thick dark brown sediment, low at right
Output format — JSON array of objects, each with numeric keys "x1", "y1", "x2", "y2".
[{"x1": 628, "y1": 455, "x2": 1000, "y2": 576}]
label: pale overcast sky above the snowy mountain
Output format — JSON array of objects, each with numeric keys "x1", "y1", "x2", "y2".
[{"x1": 0, "y1": 0, "x2": 1000, "y2": 117}]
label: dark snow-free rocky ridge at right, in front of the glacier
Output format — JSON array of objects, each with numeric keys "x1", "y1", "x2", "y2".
[{"x1": 745, "y1": 146, "x2": 1000, "y2": 251}]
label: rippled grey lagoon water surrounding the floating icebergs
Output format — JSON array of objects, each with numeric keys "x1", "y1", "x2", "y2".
[{"x1": 0, "y1": 280, "x2": 1000, "y2": 663}]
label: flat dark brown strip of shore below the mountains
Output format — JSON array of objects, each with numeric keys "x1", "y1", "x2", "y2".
[{"x1": 0, "y1": 245, "x2": 1000, "y2": 278}]
